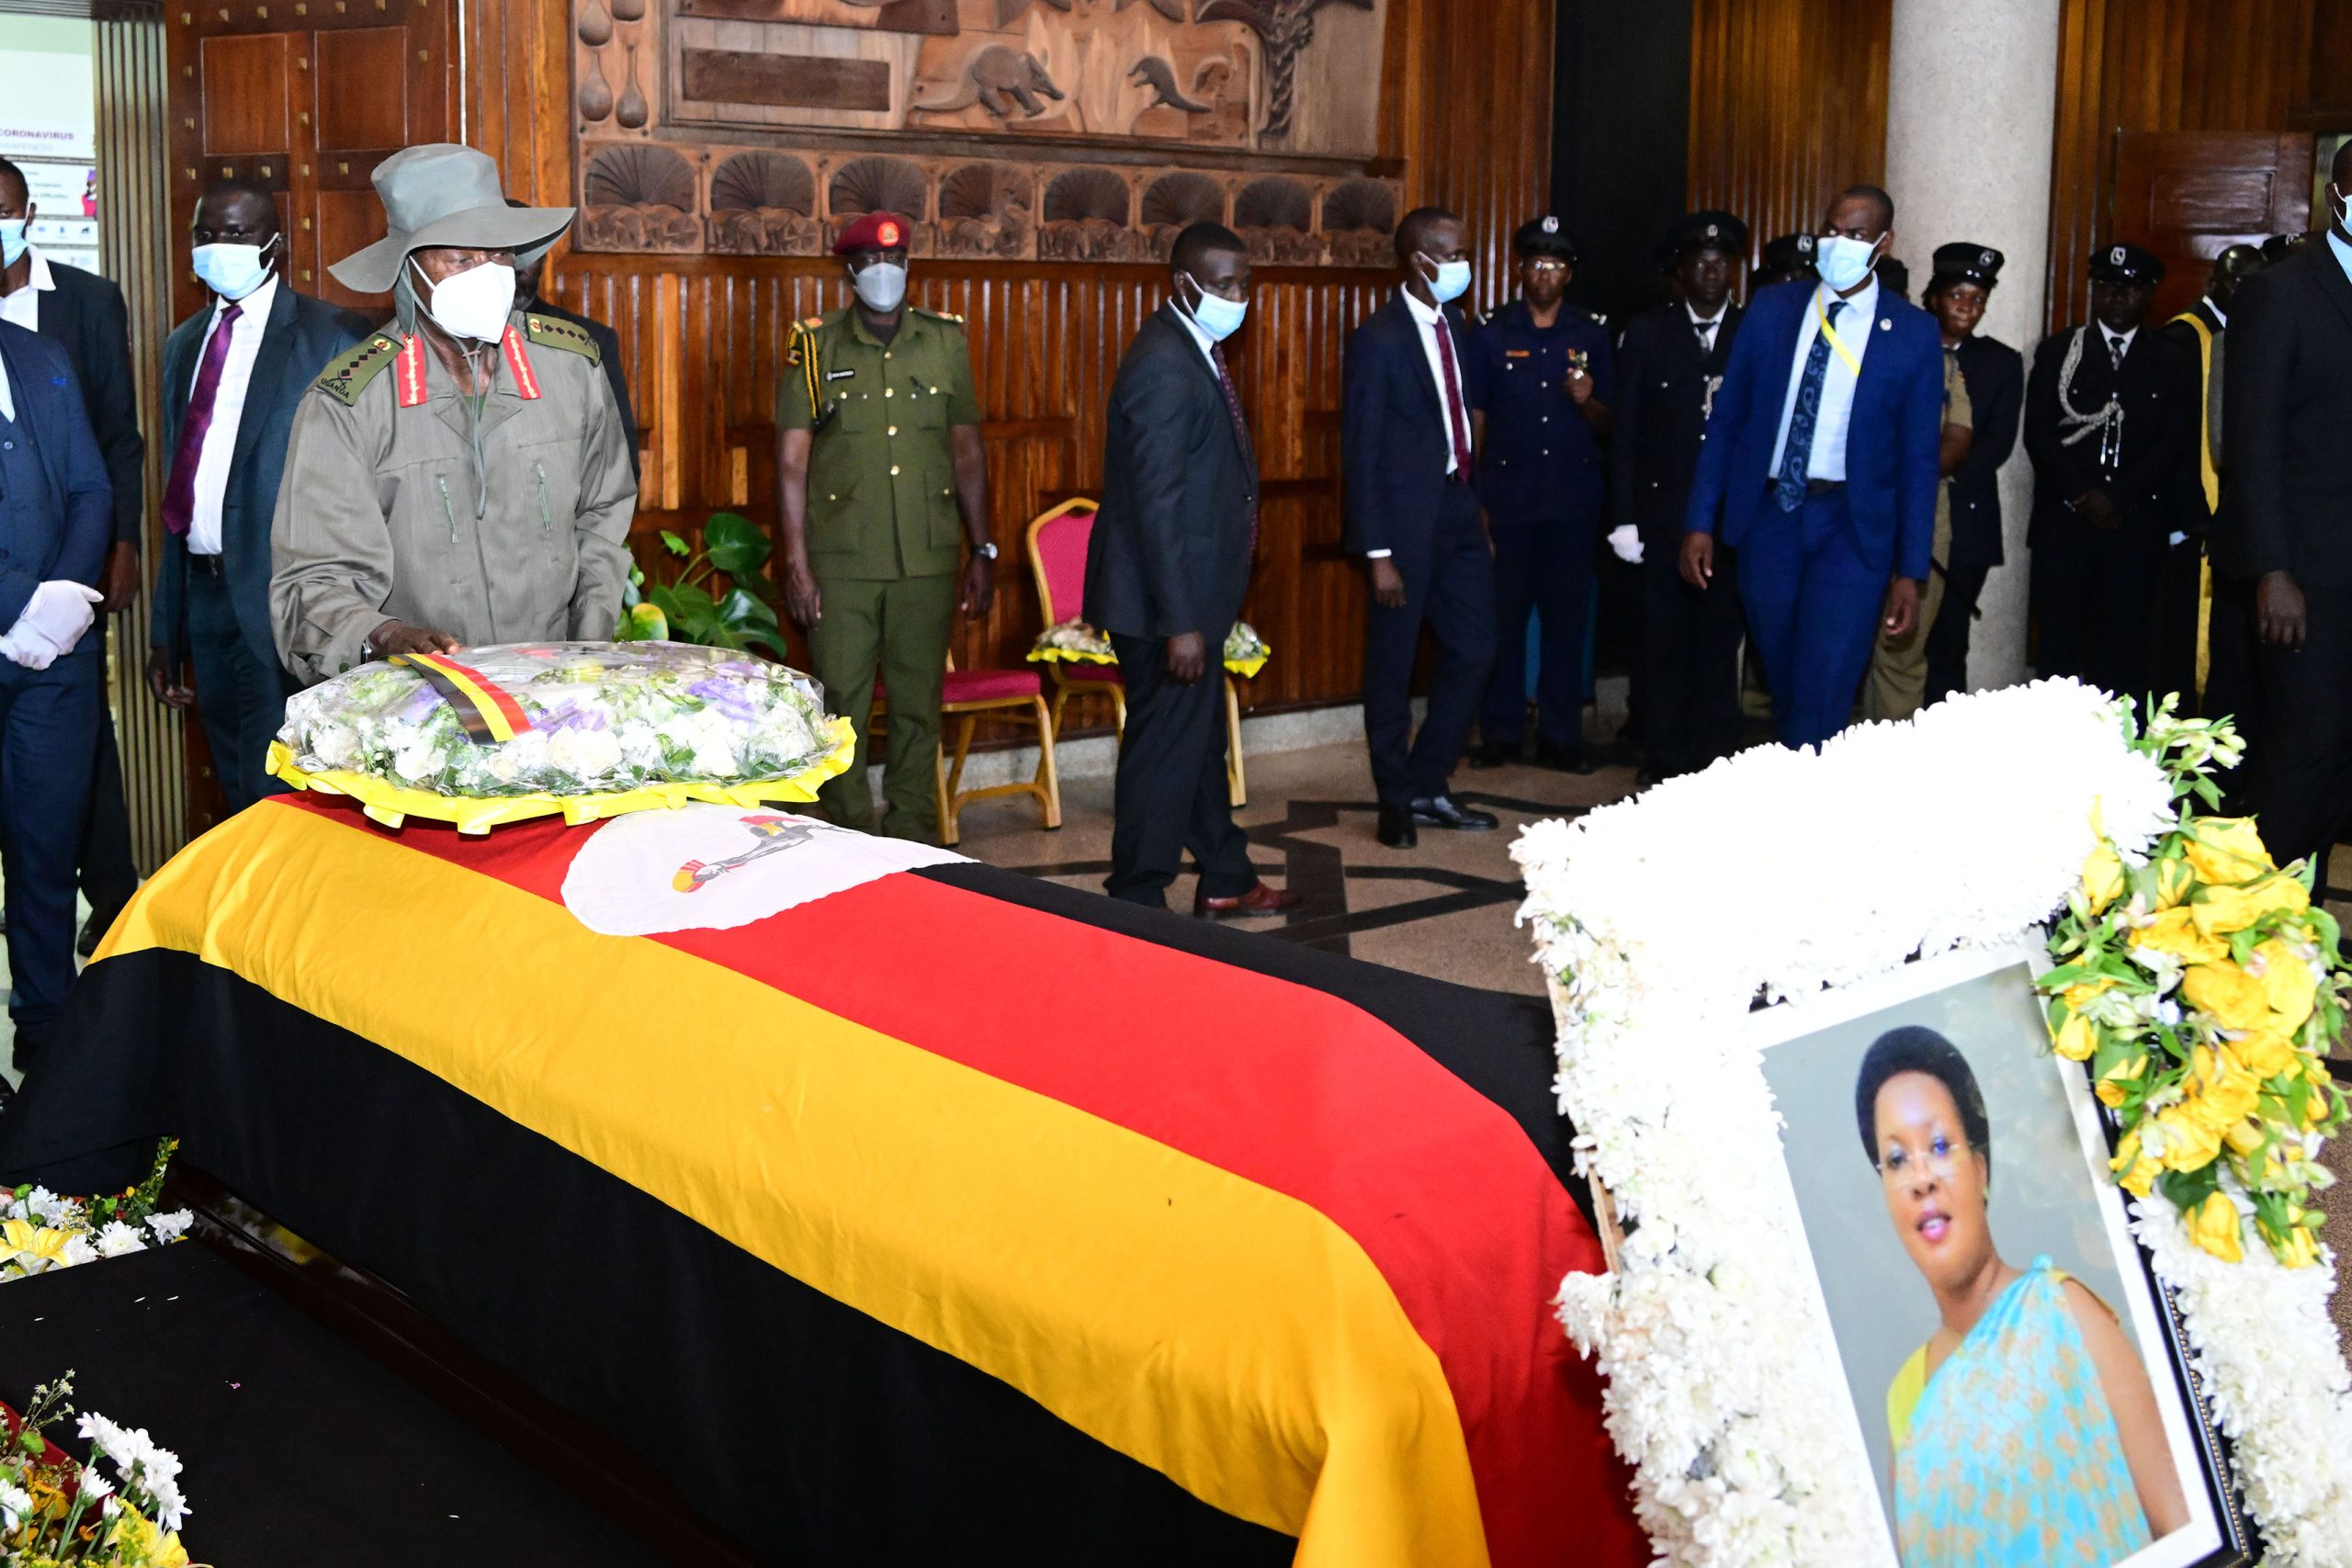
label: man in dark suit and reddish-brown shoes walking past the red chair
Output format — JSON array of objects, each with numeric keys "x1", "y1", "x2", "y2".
[{"x1": 1084, "y1": 223, "x2": 1298, "y2": 917}]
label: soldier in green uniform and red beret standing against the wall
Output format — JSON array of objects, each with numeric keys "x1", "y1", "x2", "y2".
[{"x1": 776, "y1": 211, "x2": 997, "y2": 840}]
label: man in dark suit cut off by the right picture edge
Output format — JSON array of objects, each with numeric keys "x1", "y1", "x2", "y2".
[{"x1": 2216, "y1": 143, "x2": 2352, "y2": 865}]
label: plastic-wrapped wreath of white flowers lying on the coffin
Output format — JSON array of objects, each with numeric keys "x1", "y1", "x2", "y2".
[{"x1": 277, "y1": 642, "x2": 840, "y2": 799}]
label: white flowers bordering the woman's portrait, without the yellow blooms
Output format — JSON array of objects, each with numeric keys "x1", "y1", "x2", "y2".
[{"x1": 1512, "y1": 682, "x2": 2352, "y2": 1568}]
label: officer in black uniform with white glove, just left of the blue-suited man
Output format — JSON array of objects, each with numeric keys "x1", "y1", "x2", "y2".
[{"x1": 1609, "y1": 211, "x2": 1747, "y2": 781}]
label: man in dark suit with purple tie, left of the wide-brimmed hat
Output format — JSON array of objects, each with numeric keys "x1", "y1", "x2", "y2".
[{"x1": 148, "y1": 179, "x2": 367, "y2": 811}]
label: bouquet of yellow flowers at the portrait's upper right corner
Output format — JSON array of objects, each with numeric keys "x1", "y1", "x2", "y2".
[{"x1": 2040, "y1": 703, "x2": 2352, "y2": 1269}]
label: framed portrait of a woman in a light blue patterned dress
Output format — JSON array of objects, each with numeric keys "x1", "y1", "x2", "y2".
[{"x1": 1750, "y1": 938, "x2": 2253, "y2": 1568}]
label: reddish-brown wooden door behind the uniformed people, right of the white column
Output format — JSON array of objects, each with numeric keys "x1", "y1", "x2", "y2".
[{"x1": 2100, "y1": 131, "x2": 2312, "y2": 320}]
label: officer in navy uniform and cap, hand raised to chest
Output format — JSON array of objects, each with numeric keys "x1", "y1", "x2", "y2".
[{"x1": 1470, "y1": 219, "x2": 1616, "y2": 773}]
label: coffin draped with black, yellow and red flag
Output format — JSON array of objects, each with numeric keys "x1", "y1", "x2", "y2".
[{"x1": 0, "y1": 797, "x2": 1649, "y2": 1568}]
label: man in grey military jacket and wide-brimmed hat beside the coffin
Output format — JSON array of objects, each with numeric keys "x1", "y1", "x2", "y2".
[{"x1": 270, "y1": 143, "x2": 638, "y2": 684}]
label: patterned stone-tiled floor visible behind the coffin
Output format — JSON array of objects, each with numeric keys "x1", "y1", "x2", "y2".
[{"x1": 957, "y1": 743, "x2": 1633, "y2": 992}]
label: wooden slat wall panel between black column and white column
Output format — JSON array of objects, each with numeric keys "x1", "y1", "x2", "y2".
[{"x1": 1687, "y1": 0, "x2": 1924, "y2": 270}]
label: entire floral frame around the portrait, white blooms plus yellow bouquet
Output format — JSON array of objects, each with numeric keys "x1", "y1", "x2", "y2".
[{"x1": 1512, "y1": 682, "x2": 2352, "y2": 1568}]
